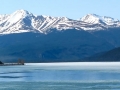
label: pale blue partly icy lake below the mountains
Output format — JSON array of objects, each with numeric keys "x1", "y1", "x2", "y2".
[{"x1": 0, "y1": 62, "x2": 120, "y2": 90}]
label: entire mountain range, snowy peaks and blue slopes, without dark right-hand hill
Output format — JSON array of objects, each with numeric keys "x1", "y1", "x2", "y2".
[{"x1": 0, "y1": 10, "x2": 120, "y2": 62}]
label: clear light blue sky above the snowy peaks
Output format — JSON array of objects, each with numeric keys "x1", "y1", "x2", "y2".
[{"x1": 0, "y1": 0, "x2": 120, "y2": 20}]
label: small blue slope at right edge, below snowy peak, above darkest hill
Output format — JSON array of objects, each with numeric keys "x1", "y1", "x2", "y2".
[{"x1": 89, "y1": 28, "x2": 120, "y2": 47}]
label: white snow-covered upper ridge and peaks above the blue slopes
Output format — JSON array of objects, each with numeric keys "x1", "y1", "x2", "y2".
[{"x1": 0, "y1": 10, "x2": 120, "y2": 34}]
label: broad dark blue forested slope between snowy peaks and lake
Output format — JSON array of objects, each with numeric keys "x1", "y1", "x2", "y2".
[{"x1": 0, "y1": 30, "x2": 114, "y2": 62}]
